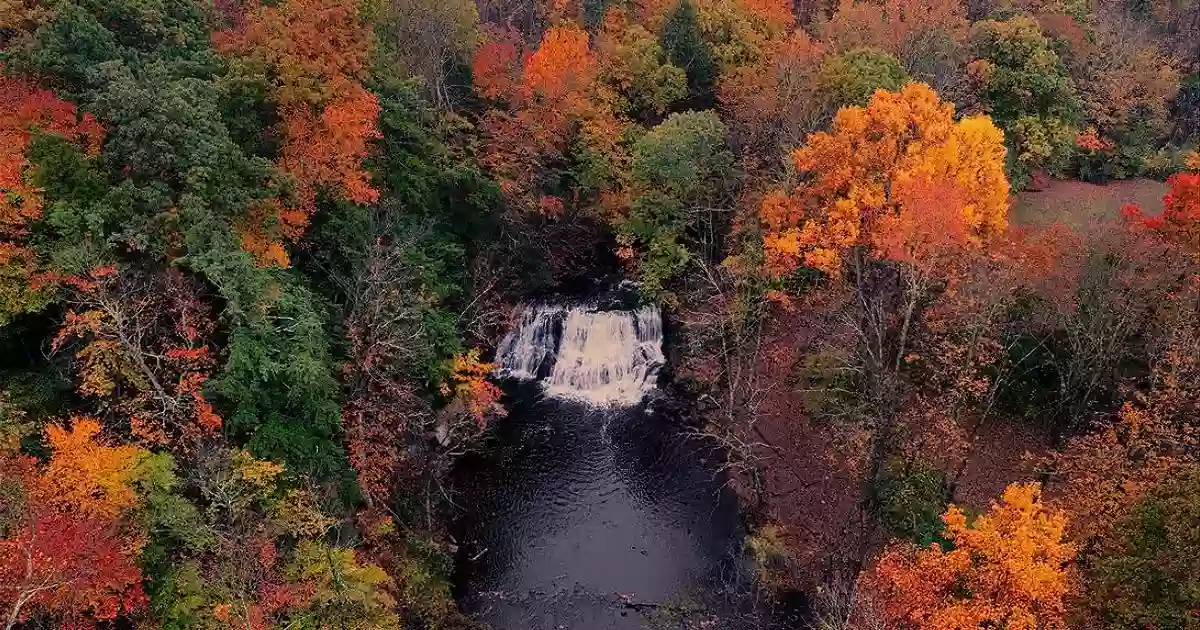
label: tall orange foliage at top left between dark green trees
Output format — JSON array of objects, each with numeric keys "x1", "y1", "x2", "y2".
[{"x1": 214, "y1": 0, "x2": 380, "y2": 266}]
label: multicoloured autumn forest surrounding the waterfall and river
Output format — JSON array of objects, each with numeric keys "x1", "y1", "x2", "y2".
[{"x1": 0, "y1": 0, "x2": 1200, "y2": 630}]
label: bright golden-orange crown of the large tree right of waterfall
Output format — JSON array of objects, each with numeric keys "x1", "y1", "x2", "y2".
[{"x1": 760, "y1": 83, "x2": 1008, "y2": 275}]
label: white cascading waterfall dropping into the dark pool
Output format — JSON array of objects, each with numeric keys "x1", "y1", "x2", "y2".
[{"x1": 497, "y1": 306, "x2": 665, "y2": 404}]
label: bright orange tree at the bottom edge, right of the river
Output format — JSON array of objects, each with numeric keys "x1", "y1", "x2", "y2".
[{"x1": 860, "y1": 484, "x2": 1075, "y2": 630}]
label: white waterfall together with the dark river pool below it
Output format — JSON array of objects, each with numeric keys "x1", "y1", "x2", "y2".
[{"x1": 455, "y1": 306, "x2": 762, "y2": 630}]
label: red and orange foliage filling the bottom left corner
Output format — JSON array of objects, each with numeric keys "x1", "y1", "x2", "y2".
[{"x1": 0, "y1": 418, "x2": 150, "y2": 628}]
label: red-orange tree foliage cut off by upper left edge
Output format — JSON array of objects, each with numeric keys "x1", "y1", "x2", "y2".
[{"x1": 0, "y1": 71, "x2": 103, "y2": 323}]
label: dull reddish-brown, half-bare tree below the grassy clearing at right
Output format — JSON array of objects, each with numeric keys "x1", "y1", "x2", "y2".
[{"x1": 1021, "y1": 211, "x2": 1195, "y2": 431}]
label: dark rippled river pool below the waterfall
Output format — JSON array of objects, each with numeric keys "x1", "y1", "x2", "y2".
[{"x1": 455, "y1": 383, "x2": 764, "y2": 630}]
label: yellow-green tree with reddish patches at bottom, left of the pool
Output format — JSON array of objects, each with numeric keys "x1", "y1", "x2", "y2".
[{"x1": 146, "y1": 448, "x2": 398, "y2": 629}]
